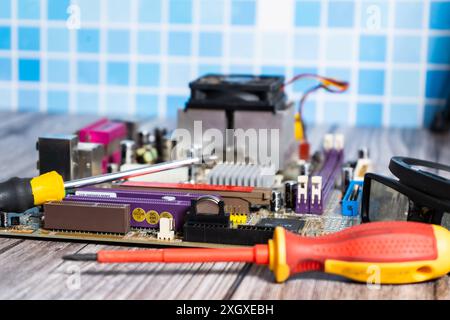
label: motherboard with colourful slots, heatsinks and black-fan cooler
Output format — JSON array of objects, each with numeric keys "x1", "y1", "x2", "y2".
[{"x1": 0, "y1": 75, "x2": 364, "y2": 247}]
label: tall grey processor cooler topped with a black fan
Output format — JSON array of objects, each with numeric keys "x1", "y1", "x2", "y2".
[{"x1": 177, "y1": 75, "x2": 297, "y2": 170}]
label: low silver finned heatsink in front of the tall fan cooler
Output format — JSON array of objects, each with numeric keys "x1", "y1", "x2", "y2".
[{"x1": 207, "y1": 163, "x2": 276, "y2": 188}]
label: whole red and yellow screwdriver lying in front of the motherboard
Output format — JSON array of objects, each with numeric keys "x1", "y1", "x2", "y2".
[{"x1": 63, "y1": 221, "x2": 450, "y2": 284}]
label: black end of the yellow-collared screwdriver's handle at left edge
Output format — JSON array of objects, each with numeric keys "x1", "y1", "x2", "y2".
[{"x1": 0, "y1": 177, "x2": 34, "y2": 212}]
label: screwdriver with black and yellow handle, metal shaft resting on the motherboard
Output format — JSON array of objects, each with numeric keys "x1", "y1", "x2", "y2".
[{"x1": 0, "y1": 156, "x2": 202, "y2": 212}]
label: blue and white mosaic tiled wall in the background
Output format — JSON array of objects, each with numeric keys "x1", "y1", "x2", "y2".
[{"x1": 0, "y1": 0, "x2": 450, "y2": 127}]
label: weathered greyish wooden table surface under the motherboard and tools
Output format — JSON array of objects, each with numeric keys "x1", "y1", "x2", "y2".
[{"x1": 0, "y1": 113, "x2": 450, "y2": 300}]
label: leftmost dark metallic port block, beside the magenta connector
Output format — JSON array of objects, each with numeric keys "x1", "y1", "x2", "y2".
[{"x1": 36, "y1": 135, "x2": 78, "y2": 181}]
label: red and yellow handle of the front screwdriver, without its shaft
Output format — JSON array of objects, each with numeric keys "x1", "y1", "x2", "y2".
[{"x1": 269, "y1": 221, "x2": 450, "y2": 284}]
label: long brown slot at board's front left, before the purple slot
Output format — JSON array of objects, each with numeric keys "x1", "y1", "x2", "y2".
[{"x1": 44, "y1": 201, "x2": 130, "y2": 233}]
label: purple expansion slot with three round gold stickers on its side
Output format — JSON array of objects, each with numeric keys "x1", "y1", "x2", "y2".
[{"x1": 64, "y1": 195, "x2": 191, "y2": 230}]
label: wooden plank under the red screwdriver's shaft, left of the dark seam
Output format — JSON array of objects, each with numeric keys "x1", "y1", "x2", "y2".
[{"x1": 7, "y1": 245, "x2": 243, "y2": 300}]
